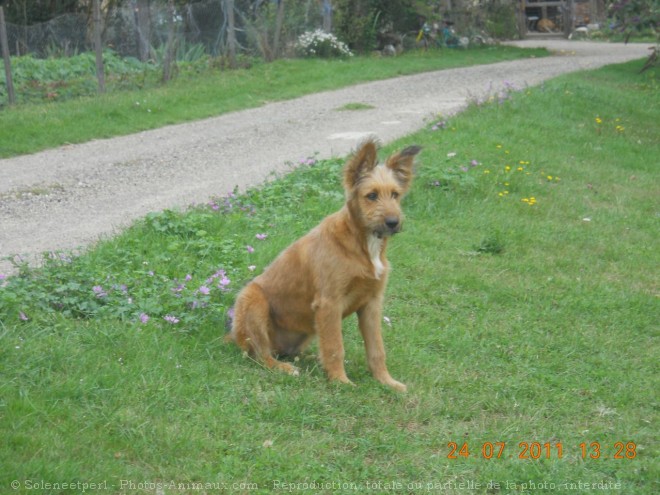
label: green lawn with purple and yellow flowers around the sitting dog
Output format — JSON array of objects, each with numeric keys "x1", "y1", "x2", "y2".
[{"x1": 0, "y1": 62, "x2": 660, "y2": 495}]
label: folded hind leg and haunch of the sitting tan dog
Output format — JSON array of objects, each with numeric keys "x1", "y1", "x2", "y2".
[{"x1": 229, "y1": 283, "x2": 299, "y2": 375}]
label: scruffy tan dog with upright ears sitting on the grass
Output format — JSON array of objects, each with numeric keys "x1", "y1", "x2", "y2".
[{"x1": 228, "y1": 141, "x2": 421, "y2": 391}]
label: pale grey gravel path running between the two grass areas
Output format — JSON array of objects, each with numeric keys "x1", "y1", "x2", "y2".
[{"x1": 0, "y1": 40, "x2": 649, "y2": 274}]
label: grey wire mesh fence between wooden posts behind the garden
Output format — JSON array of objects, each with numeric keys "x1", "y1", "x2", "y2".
[{"x1": 1, "y1": 0, "x2": 324, "y2": 60}]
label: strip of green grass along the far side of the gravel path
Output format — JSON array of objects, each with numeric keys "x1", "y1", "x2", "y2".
[{"x1": 0, "y1": 46, "x2": 547, "y2": 157}]
